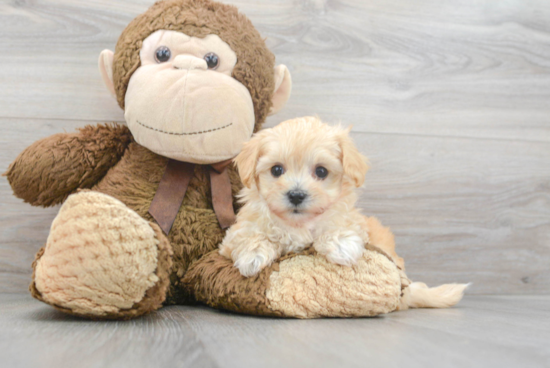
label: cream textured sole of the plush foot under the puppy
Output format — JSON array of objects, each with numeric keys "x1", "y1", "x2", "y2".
[{"x1": 266, "y1": 251, "x2": 401, "y2": 318}]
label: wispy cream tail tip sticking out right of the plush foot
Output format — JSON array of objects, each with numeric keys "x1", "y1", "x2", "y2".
[{"x1": 398, "y1": 282, "x2": 471, "y2": 310}]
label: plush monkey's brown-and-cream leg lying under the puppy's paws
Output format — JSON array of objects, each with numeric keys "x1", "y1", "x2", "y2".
[{"x1": 183, "y1": 248, "x2": 402, "y2": 318}]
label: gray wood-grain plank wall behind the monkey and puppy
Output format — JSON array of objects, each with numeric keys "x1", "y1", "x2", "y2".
[{"x1": 0, "y1": 0, "x2": 550, "y2": 294}]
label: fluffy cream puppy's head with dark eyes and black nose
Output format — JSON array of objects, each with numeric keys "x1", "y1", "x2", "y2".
[{"x1": 235, "y1": 117, "x2": 368, "y2": 226}]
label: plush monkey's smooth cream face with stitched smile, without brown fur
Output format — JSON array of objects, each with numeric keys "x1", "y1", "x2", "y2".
[{"x1": 121, "y1": 30, "x2": 254, "y2": 164}]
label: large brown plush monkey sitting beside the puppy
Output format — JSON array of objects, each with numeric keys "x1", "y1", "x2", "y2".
[{"x1": 6, "y1": 0, "x2": 407, "y2": 319}]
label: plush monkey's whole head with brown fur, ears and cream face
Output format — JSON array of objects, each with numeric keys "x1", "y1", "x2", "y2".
[{"x1": 99, "y1": 0, "x2": 292, "y2": 164}]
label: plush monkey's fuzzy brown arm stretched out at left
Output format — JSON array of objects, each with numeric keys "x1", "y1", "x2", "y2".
[{"x1": 3, "y1": 124, "x2": 132, "y2": 207}]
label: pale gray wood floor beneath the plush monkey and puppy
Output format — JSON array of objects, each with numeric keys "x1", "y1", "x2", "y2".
[{"x1": 0, "y1": 294, "x2": 550, "y2": 368}]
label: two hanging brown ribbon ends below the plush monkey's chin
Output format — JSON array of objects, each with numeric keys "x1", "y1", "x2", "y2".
[{"x1": 149, "y1": 159, "x2": 235, "y2": 235}]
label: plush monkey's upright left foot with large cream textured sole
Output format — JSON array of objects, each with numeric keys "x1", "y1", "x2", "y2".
[{"x1": 30, "y1": 191, "x2": 172, "y2": 319}]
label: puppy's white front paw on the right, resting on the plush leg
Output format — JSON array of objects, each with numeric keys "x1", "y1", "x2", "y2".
[{"x1": 314, "y1": 231, "x2": 365, "y2": 266}]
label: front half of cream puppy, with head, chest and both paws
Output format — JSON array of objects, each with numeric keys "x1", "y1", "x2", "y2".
[{"x1": 220, "y1": 117, "x2": 369, "y2": 276}]
